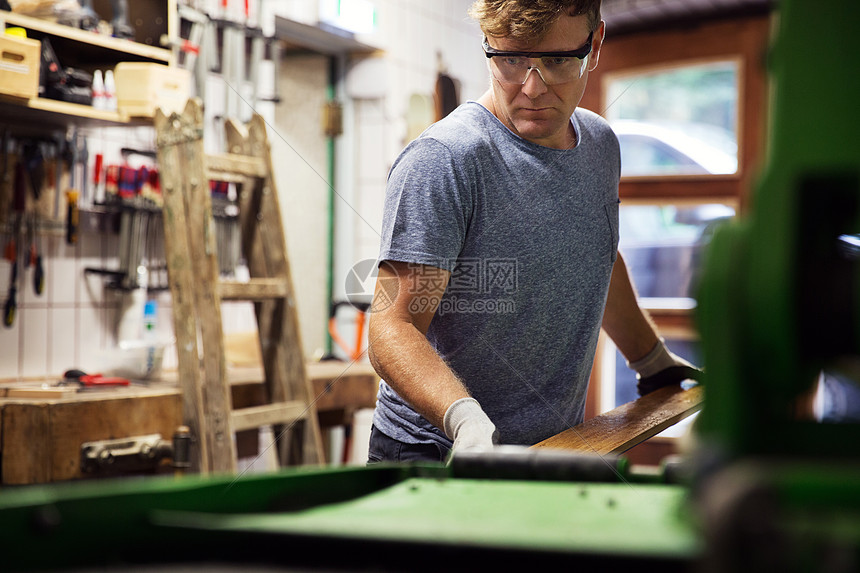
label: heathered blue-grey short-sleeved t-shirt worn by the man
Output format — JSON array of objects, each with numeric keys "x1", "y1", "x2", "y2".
[{"x1": 374, "y1": 102, "x2": 620, "y2": 447}]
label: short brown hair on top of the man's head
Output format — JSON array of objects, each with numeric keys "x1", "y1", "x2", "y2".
[{"x1": 469, "y1": 0, "x2": 601, "y2": 41}]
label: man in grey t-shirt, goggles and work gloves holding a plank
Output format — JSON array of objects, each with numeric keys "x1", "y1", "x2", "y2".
[{"x1": 368, "y1": 0, "x2": 691, "y2": 461}]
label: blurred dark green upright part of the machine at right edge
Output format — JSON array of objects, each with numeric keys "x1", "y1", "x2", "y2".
[{"x1": 693, "y1": 0, "x2": 860, "y2": 571}]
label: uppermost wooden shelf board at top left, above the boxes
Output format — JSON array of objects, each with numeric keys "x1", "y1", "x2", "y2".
[{"x1": 0, "y1": 11, "x2": 173, "y2": 65}]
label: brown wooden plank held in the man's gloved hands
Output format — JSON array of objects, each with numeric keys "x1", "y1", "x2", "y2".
[{"x1": 532, "y1": 386, "x2": 704, "y2": 455}]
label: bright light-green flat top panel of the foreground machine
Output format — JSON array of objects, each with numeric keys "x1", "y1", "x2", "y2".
[{"x1": 151, "y1": 478, "x2": 698, "y2": 559}]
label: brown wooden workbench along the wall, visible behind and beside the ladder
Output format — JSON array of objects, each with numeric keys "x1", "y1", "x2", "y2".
[{"x1": 0, "y1": 362, "x2": 378, "y2": 485}]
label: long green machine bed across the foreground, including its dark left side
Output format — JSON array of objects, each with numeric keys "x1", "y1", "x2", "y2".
[{"x1": 0, "y1": 464, "x2": 700, "y2": 571}]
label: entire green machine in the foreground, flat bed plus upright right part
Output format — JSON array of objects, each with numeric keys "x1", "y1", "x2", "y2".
[{"x1": 0, "y1": 0, "x2": 860, "y2": 572}]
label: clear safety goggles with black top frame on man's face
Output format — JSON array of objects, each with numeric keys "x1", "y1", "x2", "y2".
[{"x1": 483, "y1": 32, "x2": 594, "y2": 86}]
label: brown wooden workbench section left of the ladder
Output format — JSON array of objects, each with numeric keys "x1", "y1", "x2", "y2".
[{"x1": 0, "y1": 386, "x2": 182, "y2": 485}]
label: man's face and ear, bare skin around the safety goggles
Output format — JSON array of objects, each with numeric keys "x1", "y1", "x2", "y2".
[{"x1": 488, "y1": 15, "x2": 604, "y2": 149}]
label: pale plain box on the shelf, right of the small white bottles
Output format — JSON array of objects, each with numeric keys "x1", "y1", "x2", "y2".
[{"x1": 114, "y1": 62, "x2": 191, "y2": 117}]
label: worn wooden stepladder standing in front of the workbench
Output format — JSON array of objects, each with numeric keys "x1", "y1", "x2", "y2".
[{"x1": 155, "y1": 98, "x2": 323, "y2": 473}]
